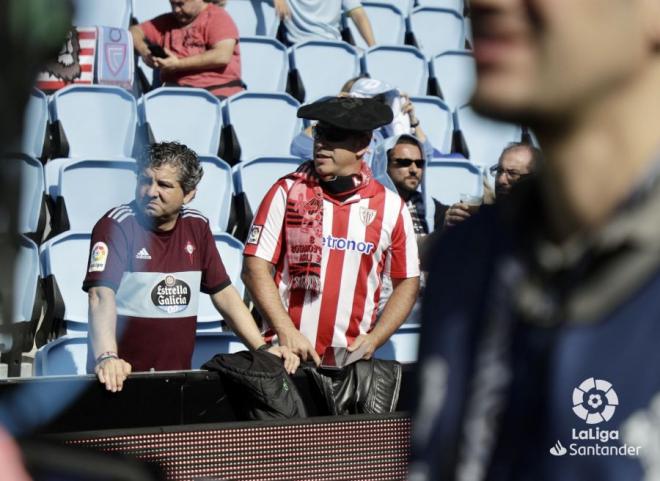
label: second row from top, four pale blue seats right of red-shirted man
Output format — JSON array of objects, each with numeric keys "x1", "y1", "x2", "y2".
[{"x1": 140, "y1": 37, "x2": 476, "y2": 109}]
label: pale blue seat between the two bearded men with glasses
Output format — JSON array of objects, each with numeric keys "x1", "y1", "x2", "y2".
[{"x1": 422, "y1": 154, "x2": 483, "y2": 229}]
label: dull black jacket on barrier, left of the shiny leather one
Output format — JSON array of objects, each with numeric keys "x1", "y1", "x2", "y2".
[{"x1": 202, "y1": 351, "x2": 307, "y2": 420}]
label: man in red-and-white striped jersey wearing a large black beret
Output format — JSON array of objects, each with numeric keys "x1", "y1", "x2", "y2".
[{"x1": 243, "y1": 98, "x2": 419, "y2": 364}]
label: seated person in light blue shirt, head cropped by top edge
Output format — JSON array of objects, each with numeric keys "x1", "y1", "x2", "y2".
[{"x1": 274, "y1": 0, "x2": 376, "y2": 47}]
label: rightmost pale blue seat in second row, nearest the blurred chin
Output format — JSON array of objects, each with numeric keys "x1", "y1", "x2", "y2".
[{"x1": 431, "y1": 50, "x2": 477, "y2": 110}]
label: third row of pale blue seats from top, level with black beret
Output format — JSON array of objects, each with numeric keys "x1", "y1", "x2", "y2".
[{"x1": 20, "y1": 85, "x2": 520, "y2": 170}]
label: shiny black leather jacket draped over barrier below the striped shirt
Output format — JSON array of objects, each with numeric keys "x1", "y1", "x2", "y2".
[{"x1": 303, "y1": 359, "x2": 402, "y2": 415}]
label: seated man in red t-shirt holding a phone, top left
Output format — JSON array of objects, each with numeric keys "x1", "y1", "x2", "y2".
[{"x1": 130, "y1": 0, "x2": 245, "y2": 97}]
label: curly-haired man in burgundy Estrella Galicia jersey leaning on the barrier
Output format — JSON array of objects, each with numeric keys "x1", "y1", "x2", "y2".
[{"x1": 83, "y1": 142, "x2": 299, "y2": 391}]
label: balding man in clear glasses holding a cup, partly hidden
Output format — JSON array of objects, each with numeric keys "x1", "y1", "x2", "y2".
[{"x1": 435, "y1": 142, "x2": 542, "y2": 228}]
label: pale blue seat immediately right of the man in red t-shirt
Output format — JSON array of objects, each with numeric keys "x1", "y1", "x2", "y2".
[{"x1": 240, "y1": 37, "x2": 289, "y2": 92}]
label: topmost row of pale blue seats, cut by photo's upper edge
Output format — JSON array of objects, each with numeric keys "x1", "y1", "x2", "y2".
[{"x1": 73, "y1": 0, "x2": 469, "y2": 57}]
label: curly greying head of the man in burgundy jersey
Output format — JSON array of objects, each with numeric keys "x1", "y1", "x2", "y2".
[{"x1": 135, "y1": 142, "x2": 203, "y2": 225}]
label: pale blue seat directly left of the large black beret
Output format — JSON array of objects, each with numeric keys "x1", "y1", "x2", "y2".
[{"x1": 224, "y1": 92, "x2": 302, "y2": 164}]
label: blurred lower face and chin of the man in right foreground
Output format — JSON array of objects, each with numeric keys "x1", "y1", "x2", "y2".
[{"x1": 470, "y1": 0, "x2": 660, "y2": 123}]
